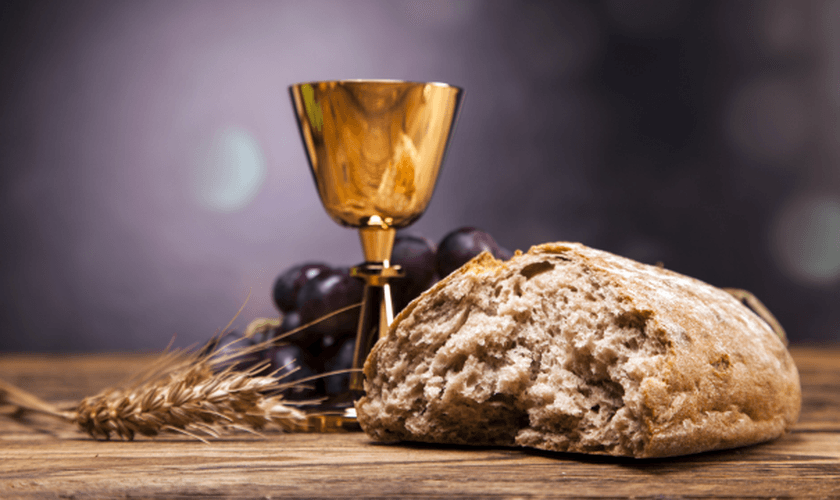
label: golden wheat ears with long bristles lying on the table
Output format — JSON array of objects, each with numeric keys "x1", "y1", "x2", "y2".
[{"x1": 0, "y1": 304, "x2": 359, "y2": 442}]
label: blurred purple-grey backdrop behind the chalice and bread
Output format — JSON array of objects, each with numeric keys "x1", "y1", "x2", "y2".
[{"x1": 0, "y1": 0, "x2": 840, "y2": 352}]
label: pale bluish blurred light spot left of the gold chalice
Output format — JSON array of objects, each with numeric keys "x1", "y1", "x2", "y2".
[{"x1": 193, "y1": 127, "x2": 266, "y2": 212}]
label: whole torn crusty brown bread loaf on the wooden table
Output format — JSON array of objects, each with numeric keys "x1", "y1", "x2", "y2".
[{"x1": 356, "y1": 243, "x2": 801, "y2": 458}]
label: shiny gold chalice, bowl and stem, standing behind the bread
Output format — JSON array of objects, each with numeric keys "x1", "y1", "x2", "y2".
[{"x1": 289, "y1": 80, "x2": 463, "y2": 413}]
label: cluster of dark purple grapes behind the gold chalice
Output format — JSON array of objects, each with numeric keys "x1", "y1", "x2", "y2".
[{"x1": 217, "y1": 227, "x2": 511, "y2": 399}]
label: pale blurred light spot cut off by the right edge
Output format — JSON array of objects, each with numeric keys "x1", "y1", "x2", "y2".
[{"x1": 773, "y1": 195, "x2": 840, "y2": 286}]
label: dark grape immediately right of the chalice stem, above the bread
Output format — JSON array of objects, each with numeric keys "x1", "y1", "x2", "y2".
[{"x1": 391, "y1": 233, "x2": 437, "y2": 311}]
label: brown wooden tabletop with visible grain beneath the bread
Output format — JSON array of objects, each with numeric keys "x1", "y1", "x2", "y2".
[{"x1": 0, "y1": 348, "x2": 840, "y2": 499}]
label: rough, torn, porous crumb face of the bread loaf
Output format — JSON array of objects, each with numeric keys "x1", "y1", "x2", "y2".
[{"x1": 369, "y1": 254, "x2": 669, "y2": 455}]
